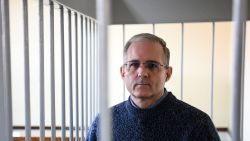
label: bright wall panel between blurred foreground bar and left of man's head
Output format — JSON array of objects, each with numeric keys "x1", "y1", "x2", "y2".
[{"x1": 108, "y1": 25, "x2": 124, "y2": 106}]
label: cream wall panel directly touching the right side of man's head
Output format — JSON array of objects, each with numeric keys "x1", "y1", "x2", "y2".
[{"x1": 155, "y1": 23, "x2": 182, "y2": 99}]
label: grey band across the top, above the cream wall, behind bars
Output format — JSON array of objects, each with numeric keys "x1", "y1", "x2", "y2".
[{"x1": 58, "y1": 0, "x2": 250, "y2": 24}]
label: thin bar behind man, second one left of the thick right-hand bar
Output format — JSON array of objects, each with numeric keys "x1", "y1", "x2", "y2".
[{"x1": 180, "y1": 23, "x2": 184, "y2": 100}]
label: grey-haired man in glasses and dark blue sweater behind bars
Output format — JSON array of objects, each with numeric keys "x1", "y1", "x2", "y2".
[{"x1": 87, "y1": 33, "x2": 220, "y2": 141}]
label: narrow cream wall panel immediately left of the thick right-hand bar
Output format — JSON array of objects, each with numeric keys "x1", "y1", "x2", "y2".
[{"x1": 213, "y1": 22, "x2": 232, "y2": 127}]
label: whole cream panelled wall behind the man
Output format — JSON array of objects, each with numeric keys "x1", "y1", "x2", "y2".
[{"x1": 108, "y1": 22, "x2": 232, "y2": 127}]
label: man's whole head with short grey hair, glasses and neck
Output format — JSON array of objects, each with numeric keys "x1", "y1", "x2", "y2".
[{"x1": 120, "y1": 33, "x2": 172, "y2": 108}]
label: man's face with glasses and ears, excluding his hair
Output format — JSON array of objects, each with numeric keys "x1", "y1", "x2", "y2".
[{"x1": 121, "y1": 40, "x2": 172, "y2": 99}]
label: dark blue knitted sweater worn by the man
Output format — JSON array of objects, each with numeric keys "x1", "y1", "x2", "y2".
[{"x1": 87, "y1": 92, "x2": 220, "y2": 141}]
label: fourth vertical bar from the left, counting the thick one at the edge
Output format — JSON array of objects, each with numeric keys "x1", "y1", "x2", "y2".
[{"x1": 49, "y1": 0, "x2": 56, "y2": 141}]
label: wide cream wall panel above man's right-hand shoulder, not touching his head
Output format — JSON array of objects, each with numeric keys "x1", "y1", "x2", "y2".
[{"x1": 183, "y1": 23, "x2": 212, "y2": 114}]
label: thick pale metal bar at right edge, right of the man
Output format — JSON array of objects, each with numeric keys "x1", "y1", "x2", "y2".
[{"x1": 229, "y1": 0, "x2": 247, "y2": 141}]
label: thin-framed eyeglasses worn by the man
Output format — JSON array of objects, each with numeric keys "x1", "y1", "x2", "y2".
[{"x1": 124, "y1": 61, "x2": 167, "y2": 72}]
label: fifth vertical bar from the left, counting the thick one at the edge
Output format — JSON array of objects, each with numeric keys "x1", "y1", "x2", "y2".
[{"x1": 60, "y1": 5, "x2": 66, "y2": 141}]
